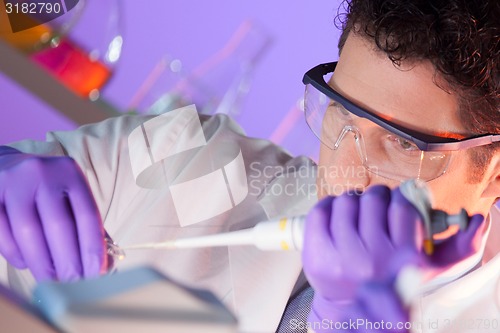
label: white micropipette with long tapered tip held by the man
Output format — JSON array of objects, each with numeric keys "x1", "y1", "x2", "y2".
[{"x1": 122, "y1": 180, "x2": 469, "y2": 255}]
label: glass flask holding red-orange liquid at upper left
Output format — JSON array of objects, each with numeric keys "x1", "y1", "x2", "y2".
[{"x1": 31, "y1": 0, "x2": 123, "y2": 100}]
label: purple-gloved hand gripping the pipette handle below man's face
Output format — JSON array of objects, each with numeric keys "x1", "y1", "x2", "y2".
[{"x1": 302, "y1": 186, "x2": 483, "y2": 330}]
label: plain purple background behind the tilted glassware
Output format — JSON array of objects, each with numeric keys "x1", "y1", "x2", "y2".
[{"x1": 0, "y1": 0, "x2": 340, "y2": 158}]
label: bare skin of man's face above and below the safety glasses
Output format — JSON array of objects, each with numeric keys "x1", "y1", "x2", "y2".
[{"x1": 318, "y1": 33, "x2": 492, "y2": 214}]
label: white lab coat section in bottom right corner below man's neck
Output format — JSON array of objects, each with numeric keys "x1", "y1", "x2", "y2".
[{"x1": 412, "y1": 207, "x2": 500, "y2": 333}]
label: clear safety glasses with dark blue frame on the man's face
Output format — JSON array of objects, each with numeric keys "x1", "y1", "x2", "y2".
[{"x1": 303, "y1": 62, "x2": 500, "y2": 181}]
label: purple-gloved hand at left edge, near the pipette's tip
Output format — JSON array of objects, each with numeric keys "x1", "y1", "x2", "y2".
[{"x1": 0, "y1": 146, "x2": 107, "y2": 281}]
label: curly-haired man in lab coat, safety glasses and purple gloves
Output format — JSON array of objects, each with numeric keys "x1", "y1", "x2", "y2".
[{"x1": 0, "y1": 0, "x2": 500, "y2": 332}]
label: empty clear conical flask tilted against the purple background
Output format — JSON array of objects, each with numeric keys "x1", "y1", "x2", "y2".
[{"x1": 131, "y1": 20, "x2": 271, "y2": 117}]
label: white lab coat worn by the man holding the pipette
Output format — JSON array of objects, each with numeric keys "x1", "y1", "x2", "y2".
[{"x1": 0, "y1": 108, "x2": 500, "y2": 332}]
